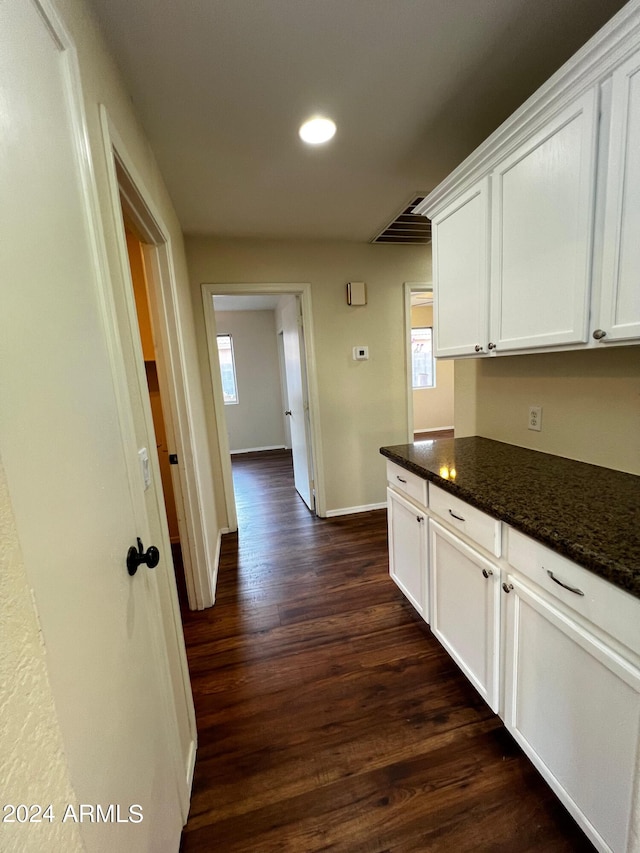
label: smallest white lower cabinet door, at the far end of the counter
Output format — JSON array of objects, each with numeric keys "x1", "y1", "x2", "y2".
[{"x1": 387, "y1": 489, "x2": 429, "y2": 622}]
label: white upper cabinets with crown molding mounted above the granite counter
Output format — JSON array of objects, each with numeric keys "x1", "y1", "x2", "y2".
[{"x1": 416, "y1": 0, "x2": 640, "y2": 358}]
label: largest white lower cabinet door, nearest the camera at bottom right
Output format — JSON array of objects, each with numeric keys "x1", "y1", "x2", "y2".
[{"x1": 503, "y1": 576, "x2": 640, "y2": 851}]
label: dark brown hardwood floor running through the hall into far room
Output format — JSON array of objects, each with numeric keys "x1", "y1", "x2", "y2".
[{"x1": 181, "y1": 452, "x2": 593, "y2": 853}]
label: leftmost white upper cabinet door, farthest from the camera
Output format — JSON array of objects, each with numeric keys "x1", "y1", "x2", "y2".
[{"x1": 432, "y1": 178, "x2": 489, "y2": 356}]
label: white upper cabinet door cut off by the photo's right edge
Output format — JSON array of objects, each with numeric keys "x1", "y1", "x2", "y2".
[{"x1": 594, "y1": 52, "x2": 640, "y2": 343}]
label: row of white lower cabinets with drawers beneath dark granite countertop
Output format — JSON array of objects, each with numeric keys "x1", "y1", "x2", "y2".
[{"x1": 387, "y1": 466, "x2": 640, "y2": 853}]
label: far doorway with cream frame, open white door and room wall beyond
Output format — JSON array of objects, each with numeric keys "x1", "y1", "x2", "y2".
[{"x1": 202, "y1": 284, "x2": 324, "y2": 531}]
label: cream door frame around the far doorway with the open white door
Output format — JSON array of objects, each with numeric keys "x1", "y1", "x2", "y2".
[{"x1": 201, "y1": 282, "x2": 327, "y2": 532}]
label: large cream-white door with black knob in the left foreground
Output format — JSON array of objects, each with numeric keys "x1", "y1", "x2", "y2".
[{"x1": 0, "y1": 0, "x2": 184, "y2": 853}]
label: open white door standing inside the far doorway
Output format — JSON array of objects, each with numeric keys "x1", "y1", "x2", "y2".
[{"x1": 281, "y1": 296, "x2": 315, "y2": 510}]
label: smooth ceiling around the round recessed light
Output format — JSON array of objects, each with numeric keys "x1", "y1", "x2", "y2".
[{"x1": 89, "y1": 0, "x2": 624, "y2": 241}]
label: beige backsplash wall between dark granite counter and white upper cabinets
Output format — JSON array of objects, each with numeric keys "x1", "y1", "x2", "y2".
[{"x1": 456, "y1": 346, "x2": 640, "y2": 474}]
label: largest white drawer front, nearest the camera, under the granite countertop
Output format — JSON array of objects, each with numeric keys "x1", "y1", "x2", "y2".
[{"x1": 507, "y1": 528, "x2": 640, "y2": 655}]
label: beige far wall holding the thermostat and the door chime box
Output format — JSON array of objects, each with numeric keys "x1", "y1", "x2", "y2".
[{"x1": 186, "y1": 237, "x2": 431, "y2": 510}]
